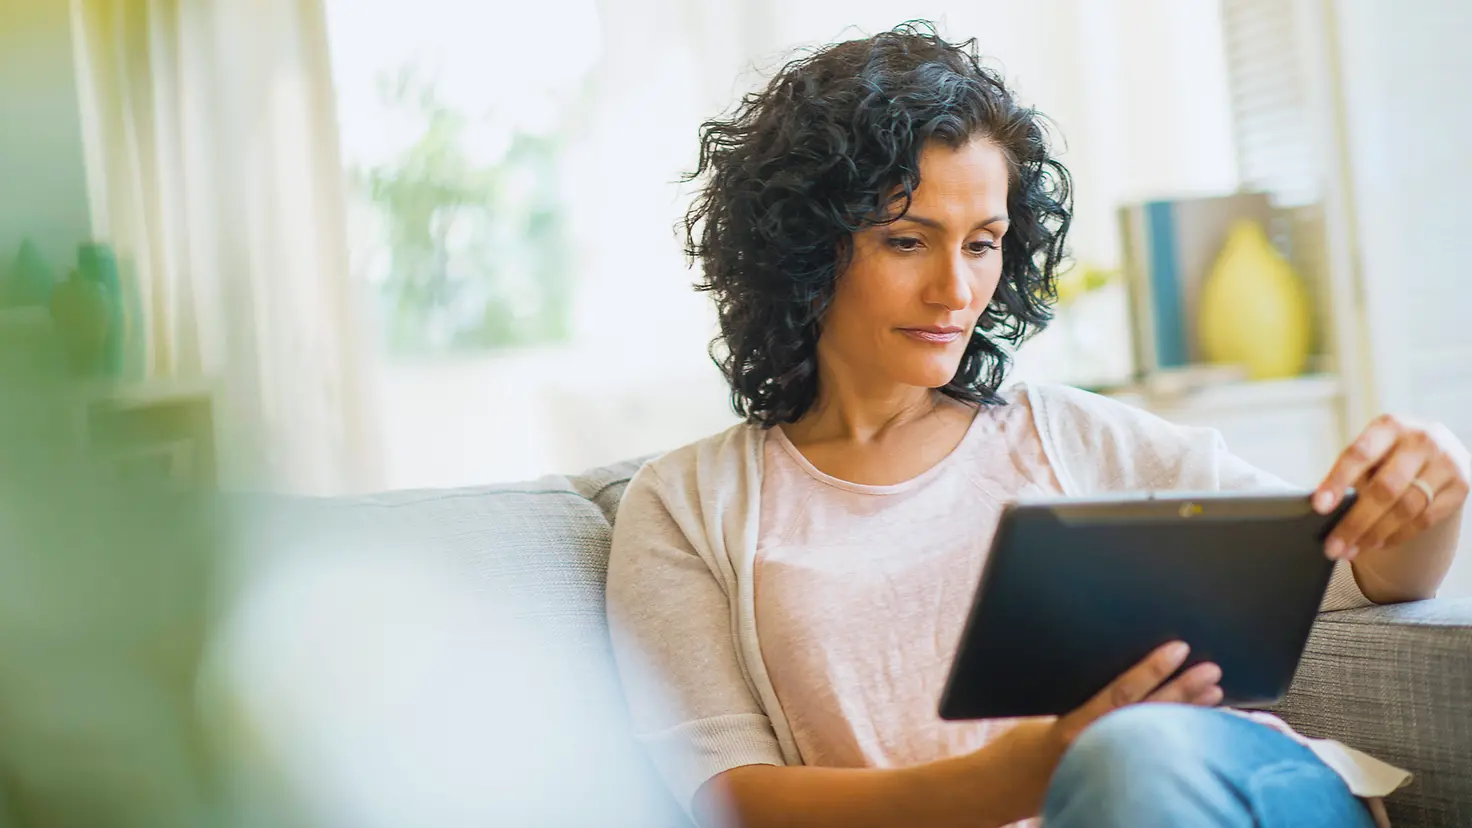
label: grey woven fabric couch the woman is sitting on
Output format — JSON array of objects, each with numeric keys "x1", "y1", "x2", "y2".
[{"x1": 316, "y1": 461, "x2": 1472, "y2": 828}]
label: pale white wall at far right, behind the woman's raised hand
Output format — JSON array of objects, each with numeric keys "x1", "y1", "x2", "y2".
[{"x1": 1331, "y1": 0, "x2": 1472, "y2": 597}]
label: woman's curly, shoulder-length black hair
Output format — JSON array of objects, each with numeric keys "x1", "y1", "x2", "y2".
[{"x1": 684, "y1": 21, "x2": 1072, "y2": 427}]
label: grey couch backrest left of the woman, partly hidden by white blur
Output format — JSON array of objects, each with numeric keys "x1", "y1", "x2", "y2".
[{"x1": 232, "y1": 461, "x2": 689, "y2": 827}]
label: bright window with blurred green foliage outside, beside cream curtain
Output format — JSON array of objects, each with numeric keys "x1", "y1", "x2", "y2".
[{"x1": 328, "y1": 0, "x2": 598, "y2": 355}]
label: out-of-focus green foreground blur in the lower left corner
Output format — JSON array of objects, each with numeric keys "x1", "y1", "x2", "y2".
[{"x1": 0, "y1": 326, "x2": 219, "y2": 828}]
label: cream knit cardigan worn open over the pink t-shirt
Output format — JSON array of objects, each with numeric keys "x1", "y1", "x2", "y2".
[{"x1": 608, "y1": 385, "x2": 1406, "y2": 809}]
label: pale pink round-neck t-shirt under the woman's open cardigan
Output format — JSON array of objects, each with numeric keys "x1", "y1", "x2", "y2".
[{"x1": 755, "y1": 395, "x2": 1061, "y2": 768}]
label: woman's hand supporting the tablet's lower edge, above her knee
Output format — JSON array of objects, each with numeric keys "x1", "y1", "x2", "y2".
[{"x1": 977, "y1": 641, "x2": 1222, "y2": 824}]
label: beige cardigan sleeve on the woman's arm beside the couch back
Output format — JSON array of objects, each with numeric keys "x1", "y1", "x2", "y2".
[{"x1": 608, "y1": 466, "x2": 783, "y2": 813}]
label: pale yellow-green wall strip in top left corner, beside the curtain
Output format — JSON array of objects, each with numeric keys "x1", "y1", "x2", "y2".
[{"x1": 0, "y1": 0, "x2": 91, "y2": 269}]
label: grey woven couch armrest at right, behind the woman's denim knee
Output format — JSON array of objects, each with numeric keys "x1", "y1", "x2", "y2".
[{"x1": 1275, "y1": 600, "x2": 1472, "y2": 828}]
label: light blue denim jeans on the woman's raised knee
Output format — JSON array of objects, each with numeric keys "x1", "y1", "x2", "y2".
[{"x1": 1044, "y1": 704, "x2": 1375, "y2": 828}]
